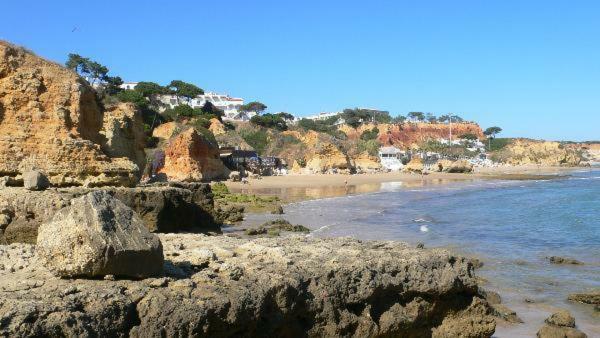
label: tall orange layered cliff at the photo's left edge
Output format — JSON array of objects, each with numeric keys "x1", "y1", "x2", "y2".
[{"x1": 0, "y1": 41, "x2": 143, "y2": 186}]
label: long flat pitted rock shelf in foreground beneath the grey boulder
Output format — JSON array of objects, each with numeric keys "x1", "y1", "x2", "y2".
[{"x1": 0, "y1": 234, "x2": 495, "y2": 337}]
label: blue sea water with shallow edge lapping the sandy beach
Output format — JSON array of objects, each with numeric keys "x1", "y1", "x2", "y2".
[{"x1": 240, "y1": 170, "x2": 600, "y2": 337}]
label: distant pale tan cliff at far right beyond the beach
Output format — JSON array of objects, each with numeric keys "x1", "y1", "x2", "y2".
[{"x1": 492, "y1": 139, "x2": 582, "y2": 166}]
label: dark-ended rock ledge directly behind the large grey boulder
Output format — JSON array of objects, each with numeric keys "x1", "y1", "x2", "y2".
[{"x1": 0, "y1": 183, "x2": 220, "y2": 243}]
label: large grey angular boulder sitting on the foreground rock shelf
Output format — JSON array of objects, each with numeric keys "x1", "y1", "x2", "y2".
[{"x1": 36, "y1": 191, "x2": 164, "y2": 278}]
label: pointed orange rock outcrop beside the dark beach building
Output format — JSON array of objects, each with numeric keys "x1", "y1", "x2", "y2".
[{"x1": 158, "y1": 128, "x2": 229, "y2": 181}]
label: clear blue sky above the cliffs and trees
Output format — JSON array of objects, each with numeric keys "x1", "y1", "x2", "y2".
[{"x1": 0, "y1": 0, "x2": 600, "y2": 140}]
